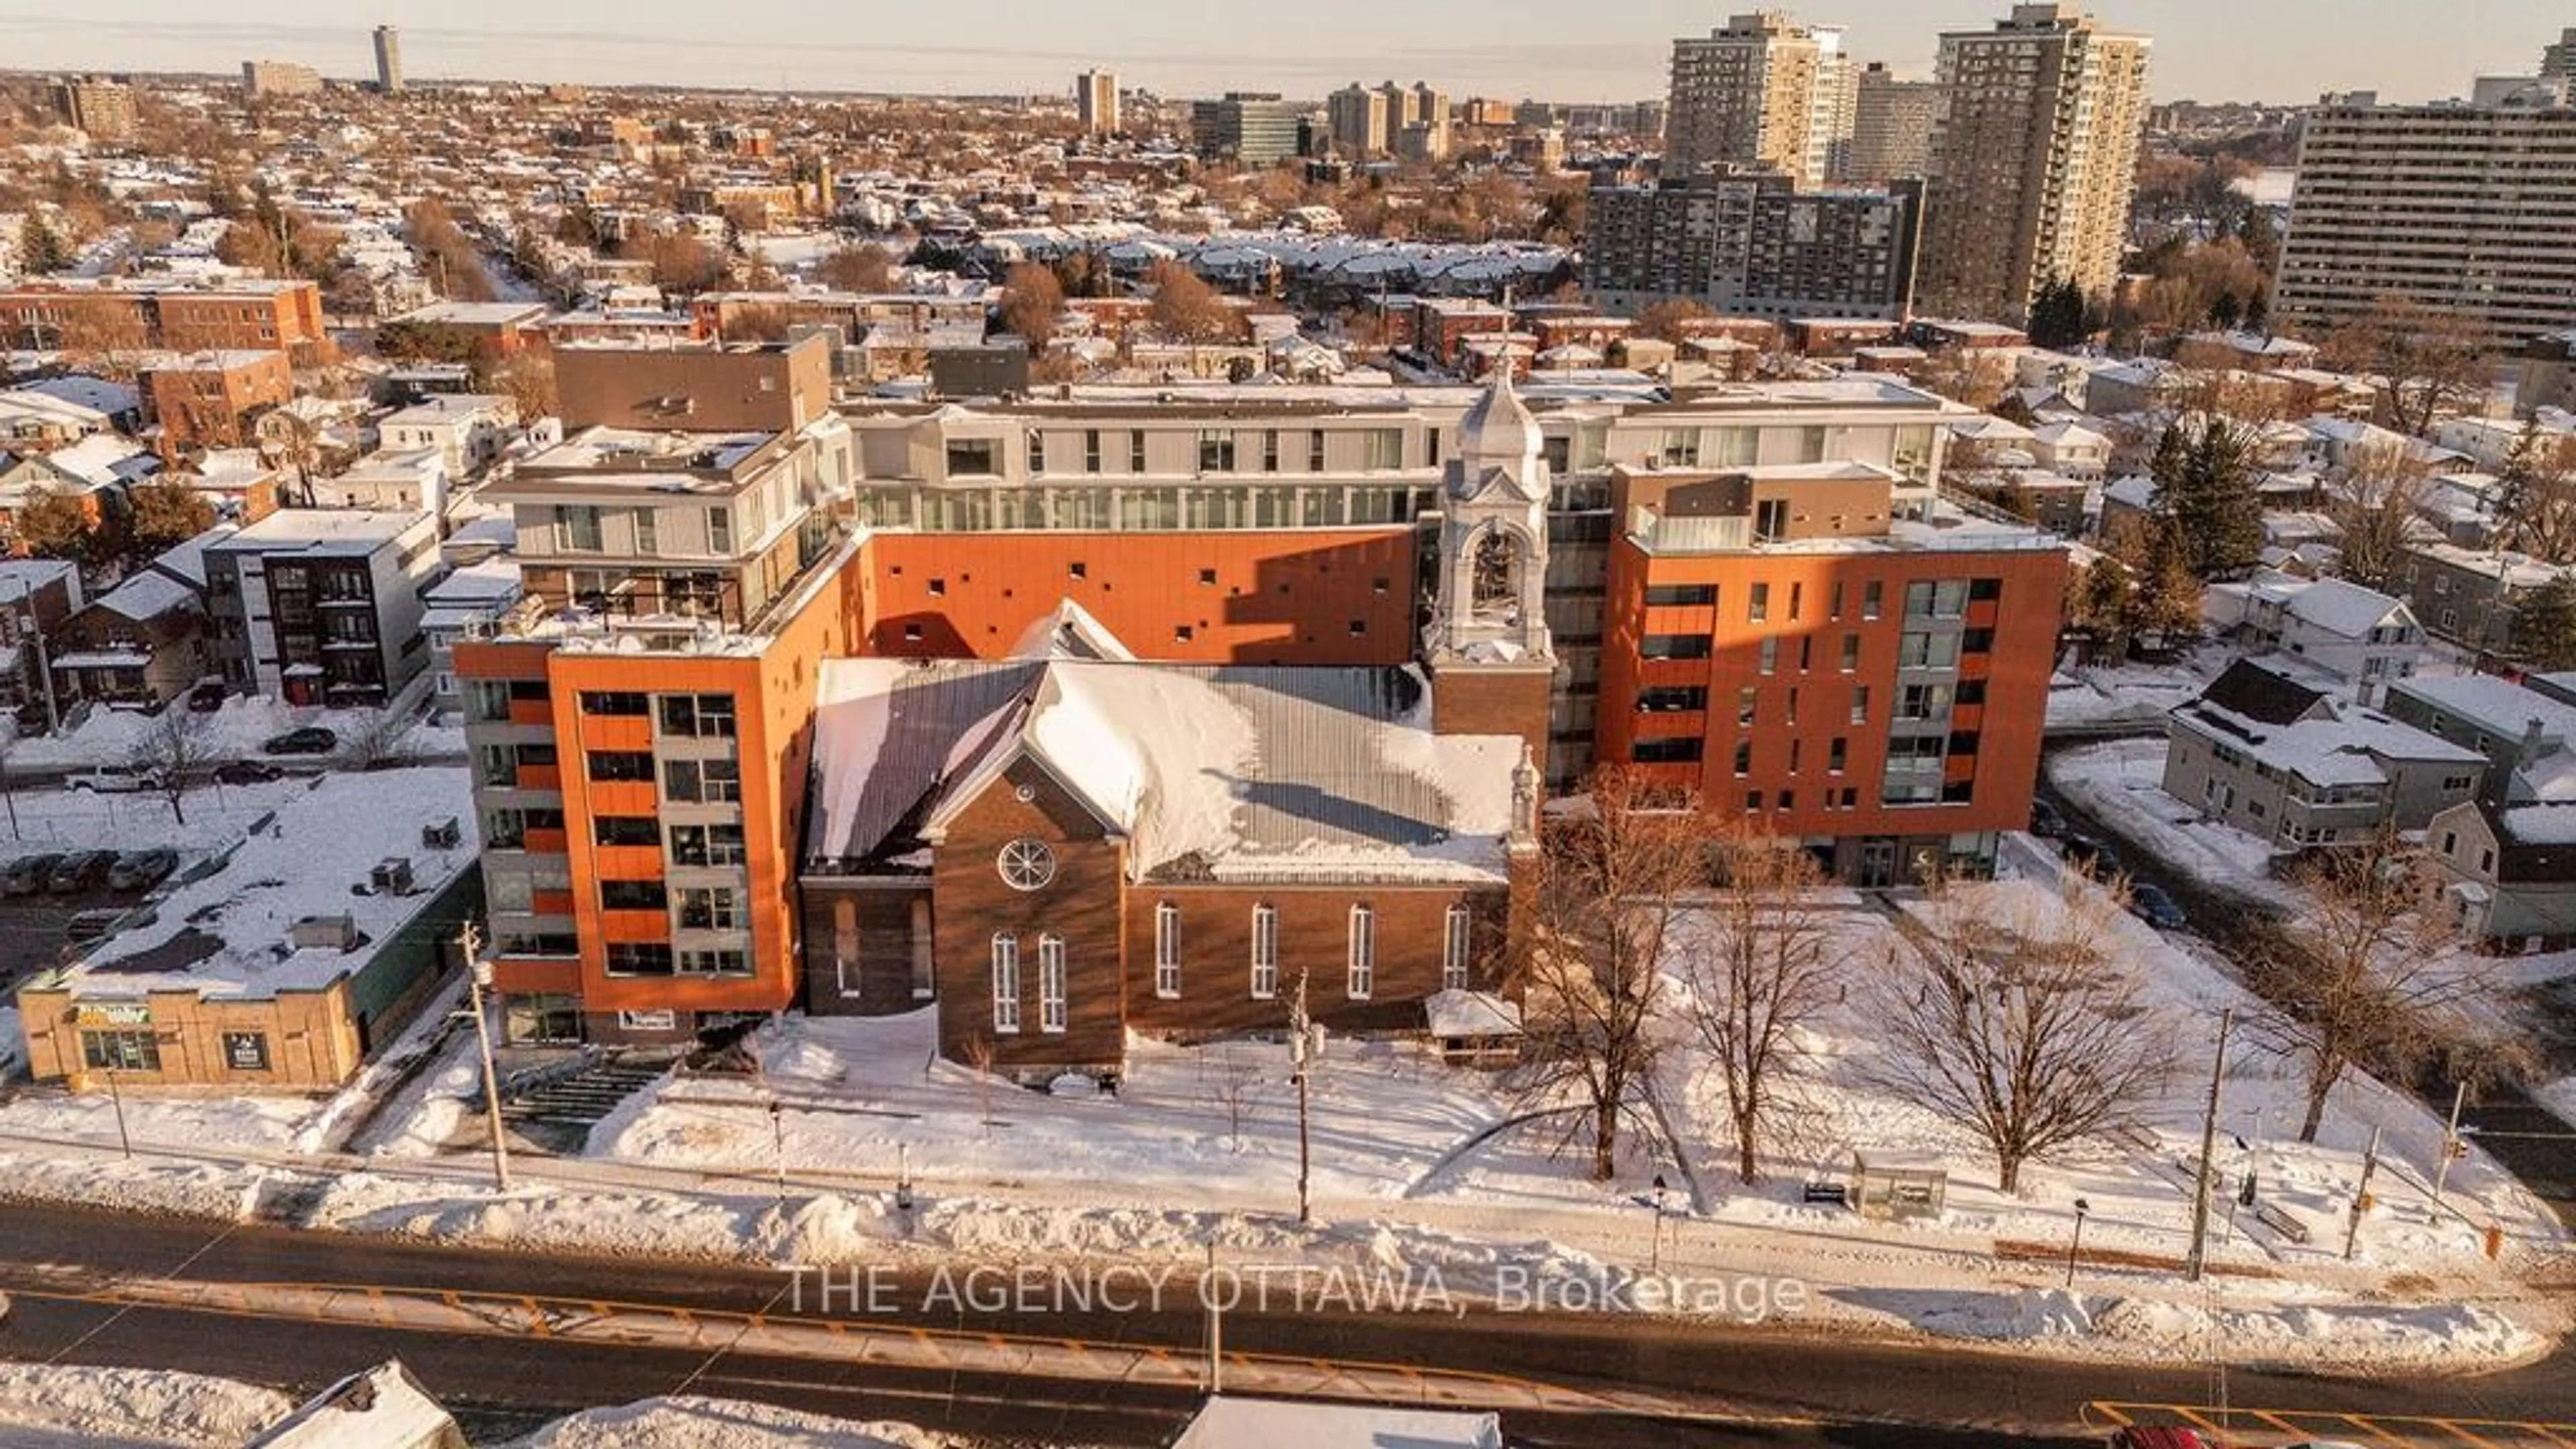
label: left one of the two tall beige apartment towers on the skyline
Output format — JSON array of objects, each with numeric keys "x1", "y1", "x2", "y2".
[{"x1": 1664, "y1": 10, "x2": 1858, "y2": 186}]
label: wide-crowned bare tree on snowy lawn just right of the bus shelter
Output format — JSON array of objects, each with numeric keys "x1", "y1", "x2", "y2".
[{"x1": 1870, "y1": 877, "x2": 2171, "y2": 1194}]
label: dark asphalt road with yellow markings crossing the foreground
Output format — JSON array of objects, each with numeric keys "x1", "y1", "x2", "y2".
[{"x1": 0, "y1": 1207, "x2": 2576, "y2": 1449}]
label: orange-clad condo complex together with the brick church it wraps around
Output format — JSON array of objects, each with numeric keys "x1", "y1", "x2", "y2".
[{"x1": 456, "y1": 337, "x2": 2066, "y2": 1057}]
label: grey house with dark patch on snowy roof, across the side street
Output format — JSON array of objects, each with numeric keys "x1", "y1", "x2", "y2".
[{"x1": 2164, "y1": 660, "x2": 2486, "y2": 851}]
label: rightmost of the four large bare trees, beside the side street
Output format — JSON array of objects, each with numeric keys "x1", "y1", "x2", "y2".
[{"x1": 2251, "y1": 828, "x2": 2509, "y2": 1142}]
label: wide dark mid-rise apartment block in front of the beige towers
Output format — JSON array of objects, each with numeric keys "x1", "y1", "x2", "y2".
[{"x1": 1585, "y1": 173, "x2": 1922, "y2": 322}]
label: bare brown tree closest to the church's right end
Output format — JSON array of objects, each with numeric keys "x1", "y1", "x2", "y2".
[{"x1": 1520, "y1": 768, "x2": 1708, "y2": 1181}]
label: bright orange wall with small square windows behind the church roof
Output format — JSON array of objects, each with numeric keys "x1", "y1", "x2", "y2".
[{"x1": 865, "y1": 526, "x2": 1414, "y2": 665}]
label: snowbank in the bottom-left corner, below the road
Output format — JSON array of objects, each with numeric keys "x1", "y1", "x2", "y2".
[{"x1": 0, "y1": 1364, "x2": 297, "y2": 1449}]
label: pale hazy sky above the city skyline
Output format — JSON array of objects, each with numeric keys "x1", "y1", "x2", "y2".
[{"x1": 0, "y1": 0, "x2": 2576, "y2": 103}]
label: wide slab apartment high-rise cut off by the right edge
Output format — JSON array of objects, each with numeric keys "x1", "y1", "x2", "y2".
[{"x1": 2272, "y1": 48, "x2": 2576, "y2": 348}]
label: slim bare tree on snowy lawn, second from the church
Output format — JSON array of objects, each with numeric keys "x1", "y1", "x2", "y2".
[{"x1": 1684, "y1": 835, "x2": 1842, "y2": 1183}]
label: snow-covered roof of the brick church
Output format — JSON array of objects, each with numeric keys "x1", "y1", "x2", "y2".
[{"x1": 809, "y1": 660, "x2": 1522, "y2": 881}]
